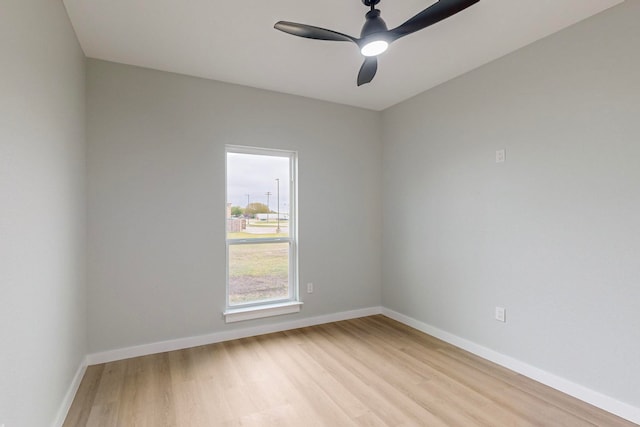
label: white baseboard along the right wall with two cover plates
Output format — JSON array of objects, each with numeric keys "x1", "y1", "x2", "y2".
[{"x1": 382, "y1": 308, "x2": 640, "y2": 424}]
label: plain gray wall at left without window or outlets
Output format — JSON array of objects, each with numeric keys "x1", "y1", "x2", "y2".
[{"x1": 0, "y1": 0, "x2": 87, "y2": 427}]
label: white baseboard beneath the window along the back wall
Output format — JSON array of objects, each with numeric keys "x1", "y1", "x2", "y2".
[{"x1": 87, "y1": 307, "x2": 382, "y2": 365}]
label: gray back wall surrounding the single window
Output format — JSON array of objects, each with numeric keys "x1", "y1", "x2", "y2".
[{"x1": 87, "y1": 60, "x2": 382, "y2": 352}]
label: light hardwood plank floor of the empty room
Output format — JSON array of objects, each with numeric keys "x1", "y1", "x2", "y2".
[{"x1": 64, "y1": 316, "x2": 635, "y2": 427}]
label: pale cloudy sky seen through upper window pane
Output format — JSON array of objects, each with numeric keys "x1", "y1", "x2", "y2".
[{"x1": 227, "y1": 153, "x2": 290, "y2": 212}]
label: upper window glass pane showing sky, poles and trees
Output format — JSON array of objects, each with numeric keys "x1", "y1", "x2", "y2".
[{"x1": 227, "y1": 152, "x2": 291, "y2": 239}]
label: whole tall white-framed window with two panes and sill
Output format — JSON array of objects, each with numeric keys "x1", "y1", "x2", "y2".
[{"x1": 224, "y1": 146, "x2": 301, "y2": 322}]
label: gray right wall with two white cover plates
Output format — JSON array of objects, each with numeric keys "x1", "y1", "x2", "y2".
[{"x1": 383, "y1": 1, "x2": 640, "y2": 407}]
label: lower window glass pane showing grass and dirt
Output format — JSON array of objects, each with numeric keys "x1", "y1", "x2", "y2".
[{"x1": 229, "y1": 242, "x2": 289, "y2": 306}]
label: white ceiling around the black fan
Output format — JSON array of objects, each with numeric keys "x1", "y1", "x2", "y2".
[{"x1": 63, "y1": 0, "x2": 624, "y2": 110}]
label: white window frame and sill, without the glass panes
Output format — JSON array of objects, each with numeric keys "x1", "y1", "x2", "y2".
[{"x1": 223, "y1": 145, "x2": 302, "y2": 323}]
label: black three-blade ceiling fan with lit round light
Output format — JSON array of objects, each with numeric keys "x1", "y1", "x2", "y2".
[{"x1": 274, "y1": 0, "x2": 480, "y2": 86}]
